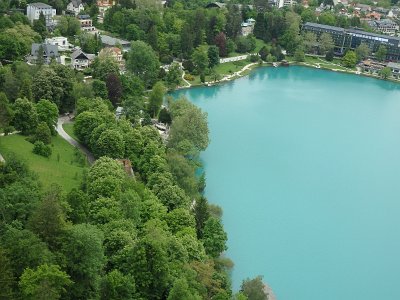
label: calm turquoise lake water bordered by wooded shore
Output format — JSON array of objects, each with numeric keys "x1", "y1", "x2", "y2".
[{"x1": 175, "y1": 67, "x2": 400, "y2": 300}]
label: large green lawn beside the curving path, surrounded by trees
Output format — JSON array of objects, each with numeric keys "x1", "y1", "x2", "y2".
[{"x1": 0, "y1": 134, "x2": 84, "y2": 191}]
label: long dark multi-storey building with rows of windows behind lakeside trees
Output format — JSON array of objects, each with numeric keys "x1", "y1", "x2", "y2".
[{"x1": 302, "y1": 22, "x2": 400, "y2": 61}]
